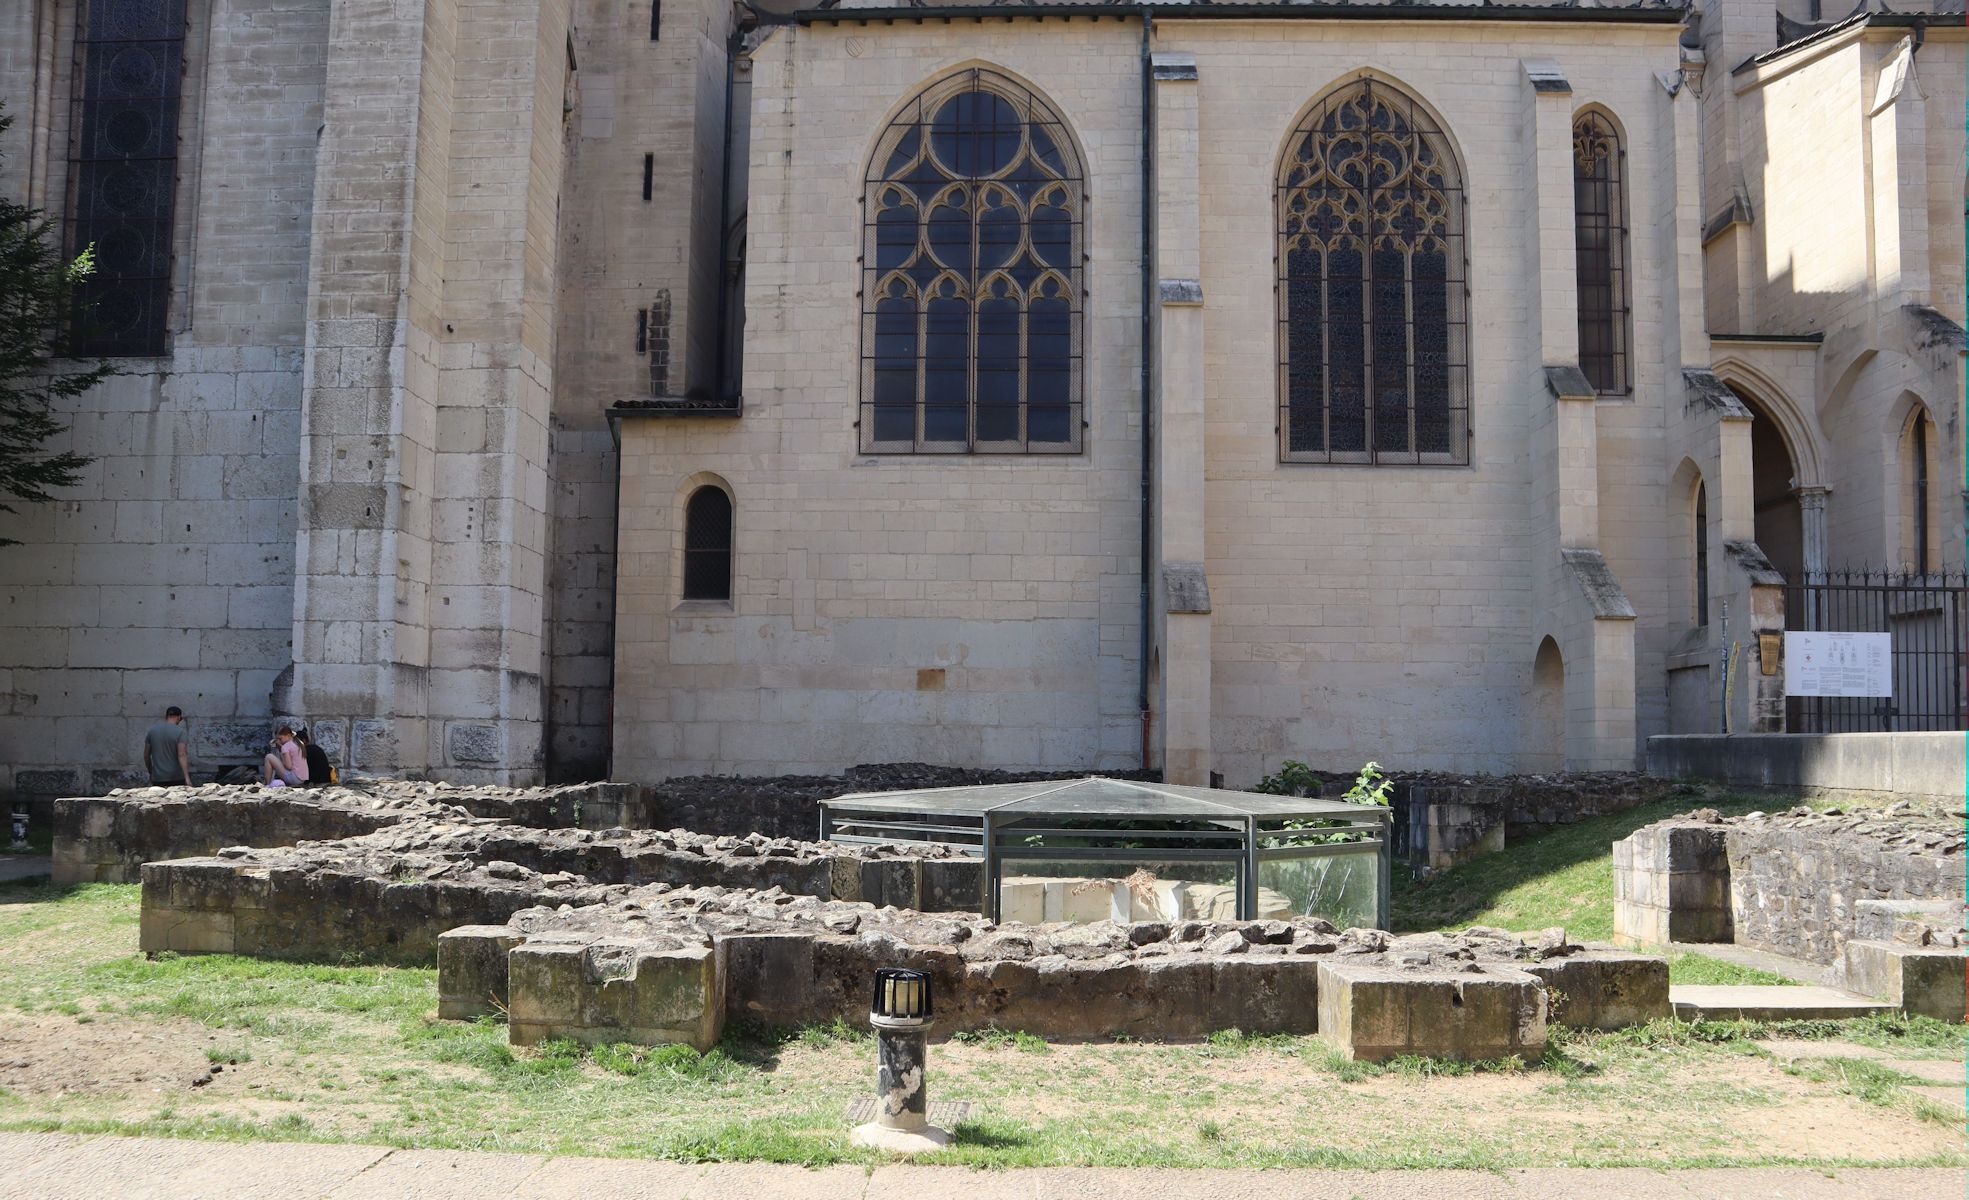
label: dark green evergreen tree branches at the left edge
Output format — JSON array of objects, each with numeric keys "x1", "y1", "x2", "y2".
[{"x1": 0, "y1": 104, "x2": 118, "y2": 546}]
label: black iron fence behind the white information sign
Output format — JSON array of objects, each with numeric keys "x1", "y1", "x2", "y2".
[{"x1": 1784, "y1": 569, "x2": 1969, "y2": 733}]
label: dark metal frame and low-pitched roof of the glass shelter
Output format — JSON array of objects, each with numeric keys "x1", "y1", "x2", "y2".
[{"x1": 821, "y1": 776, "x2": 1394, "y2": 928}]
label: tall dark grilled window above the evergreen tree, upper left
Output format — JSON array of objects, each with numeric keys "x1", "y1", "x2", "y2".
[{"x1": 67, "y1": 0, "x2": 185, "y2": 357}]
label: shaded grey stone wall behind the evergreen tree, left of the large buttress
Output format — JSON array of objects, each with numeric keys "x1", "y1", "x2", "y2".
[{"x1": 0, "y1": 0, "x2": 329, "y2": 800}]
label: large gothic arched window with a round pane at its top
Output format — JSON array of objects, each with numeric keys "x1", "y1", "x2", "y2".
[{"x1": 857, "y1": 69, "x2": 1087, "y2": 453}]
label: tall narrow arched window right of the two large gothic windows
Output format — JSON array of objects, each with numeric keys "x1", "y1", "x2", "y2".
[{"x1": 1573, "y1": 108, "x2": 1632, "y2": 396}]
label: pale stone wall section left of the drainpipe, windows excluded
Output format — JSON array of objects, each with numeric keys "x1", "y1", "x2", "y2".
[{"x1": 614, "y1": 20, "x2": 1140, "y2": 778}]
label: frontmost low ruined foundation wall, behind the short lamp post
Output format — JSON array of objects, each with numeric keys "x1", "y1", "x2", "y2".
[{"x1": 437, "y1": 887, "x2": 1670, "y2": 1058}]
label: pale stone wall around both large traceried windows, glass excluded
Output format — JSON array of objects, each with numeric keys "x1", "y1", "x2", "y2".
[{"x1": 614, "y1": 20, "x2": 1701, "y2": 786}]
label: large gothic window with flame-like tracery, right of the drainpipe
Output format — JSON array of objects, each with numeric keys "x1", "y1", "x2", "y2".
[{"x1": 1278, "y1": 79, "x2": 1469, "y2": 463}]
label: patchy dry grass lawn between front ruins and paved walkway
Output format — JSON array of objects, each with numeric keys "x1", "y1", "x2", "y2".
[{"x1": 0, "y1": 885, "x2": 1969, "y2": 1167}]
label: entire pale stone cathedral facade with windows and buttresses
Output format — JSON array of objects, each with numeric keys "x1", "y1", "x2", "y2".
[{"x1": 0, "y1": 0, "x2": 1965, "y2": 794}]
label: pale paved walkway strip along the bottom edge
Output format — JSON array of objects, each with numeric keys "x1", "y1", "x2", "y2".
[{"x1": 0, "y1": 1133, "x2": 1965, "y2": 1200}]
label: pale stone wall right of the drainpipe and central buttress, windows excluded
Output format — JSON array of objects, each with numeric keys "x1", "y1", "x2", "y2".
[{"x1": 1162, "y1": 22, "x2": 1682, "y2": 784}]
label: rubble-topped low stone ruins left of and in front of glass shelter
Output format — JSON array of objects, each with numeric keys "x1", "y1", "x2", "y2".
[{"x1": 55, "y1": 772, "x2": 1693, "y2": 1060}]
